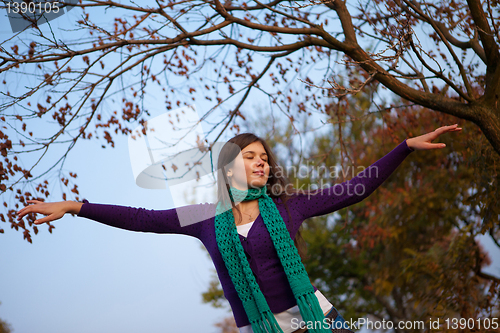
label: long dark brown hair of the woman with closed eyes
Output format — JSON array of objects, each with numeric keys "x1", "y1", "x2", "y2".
[{"x1": 217, "y1": 133, "x2": 307, "y2": 259}]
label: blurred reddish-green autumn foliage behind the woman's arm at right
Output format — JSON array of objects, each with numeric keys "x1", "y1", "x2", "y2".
[{"x1": 203, "y1": 86, "x2": 500, "y2": 332}]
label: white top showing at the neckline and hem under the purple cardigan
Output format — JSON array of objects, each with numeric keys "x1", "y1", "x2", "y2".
[{"x1": 236, "y1": 221, "x2": 333, "y2": 333}]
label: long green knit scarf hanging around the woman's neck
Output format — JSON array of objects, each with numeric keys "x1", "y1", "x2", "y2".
[{"x1": 215, "y1": 186, "x2": 331, "y2": 333}]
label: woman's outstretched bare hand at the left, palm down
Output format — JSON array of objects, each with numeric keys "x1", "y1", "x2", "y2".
[{"x1": 17, "y1": 200, "x2": 81, "y2": 224}]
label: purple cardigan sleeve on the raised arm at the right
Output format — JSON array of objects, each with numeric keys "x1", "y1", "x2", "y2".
[{"x1": 291, "y1": 140, "x2": 413, "y2": 223}]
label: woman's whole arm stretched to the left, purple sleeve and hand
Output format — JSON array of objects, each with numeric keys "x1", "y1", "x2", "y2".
[{"x1": 18, "y1": 200, "x2": 213, "y2": 238}]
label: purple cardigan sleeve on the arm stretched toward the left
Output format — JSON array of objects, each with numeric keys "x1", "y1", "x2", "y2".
[{"x1": 78, "y1": 200, "x2": 214, "y2": 238}]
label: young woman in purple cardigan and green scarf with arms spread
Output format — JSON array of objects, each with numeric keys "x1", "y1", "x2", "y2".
[{"x1": 14, "y1": 124, "x2": 461, "y2": 333}]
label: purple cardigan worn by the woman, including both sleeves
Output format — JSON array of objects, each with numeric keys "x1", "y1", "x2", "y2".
[{"x1": 78, "y1": 140, "x2": 413, "y2": 327}]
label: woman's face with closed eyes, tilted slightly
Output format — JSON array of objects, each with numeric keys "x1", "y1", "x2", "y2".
[{"x1": 227, "y1": 141, "x2": 269, "y2": 190}]
